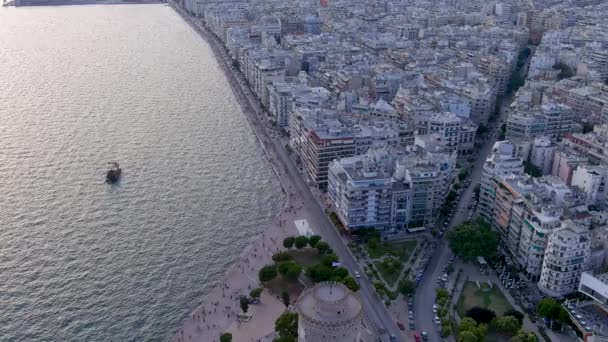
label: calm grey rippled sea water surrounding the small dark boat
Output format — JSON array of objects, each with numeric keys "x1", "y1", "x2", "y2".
[{"x1": 0, "y1": 5, "x2": 283, "y2": 341}]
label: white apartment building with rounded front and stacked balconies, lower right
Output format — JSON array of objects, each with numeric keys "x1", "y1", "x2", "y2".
[{"x1": 538, "y1": 220, "x2": 591, "y2": 298}]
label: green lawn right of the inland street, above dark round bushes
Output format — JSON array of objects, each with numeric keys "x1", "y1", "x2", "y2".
[{"x1": 457, "y1": 281, "x2": 513, "y2": 317}]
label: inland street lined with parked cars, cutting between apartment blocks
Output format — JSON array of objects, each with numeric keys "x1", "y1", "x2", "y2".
[{"x1": 414, "y1": 98, "x2": 512, "y2": 341}]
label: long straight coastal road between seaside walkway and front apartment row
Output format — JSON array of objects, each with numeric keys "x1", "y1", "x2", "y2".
[{"x1": 174, "y1": 5, "x2": 406, "y2": 341}]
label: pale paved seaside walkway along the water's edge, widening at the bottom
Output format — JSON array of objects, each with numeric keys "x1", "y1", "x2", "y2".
[{"x1": 168, "y1": 1, "x2": 306, "y2": 342}]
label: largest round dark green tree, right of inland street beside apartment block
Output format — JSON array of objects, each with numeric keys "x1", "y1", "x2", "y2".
[{"x1": 447, "y1": 218, "x2": 498, "y2": 261}]
